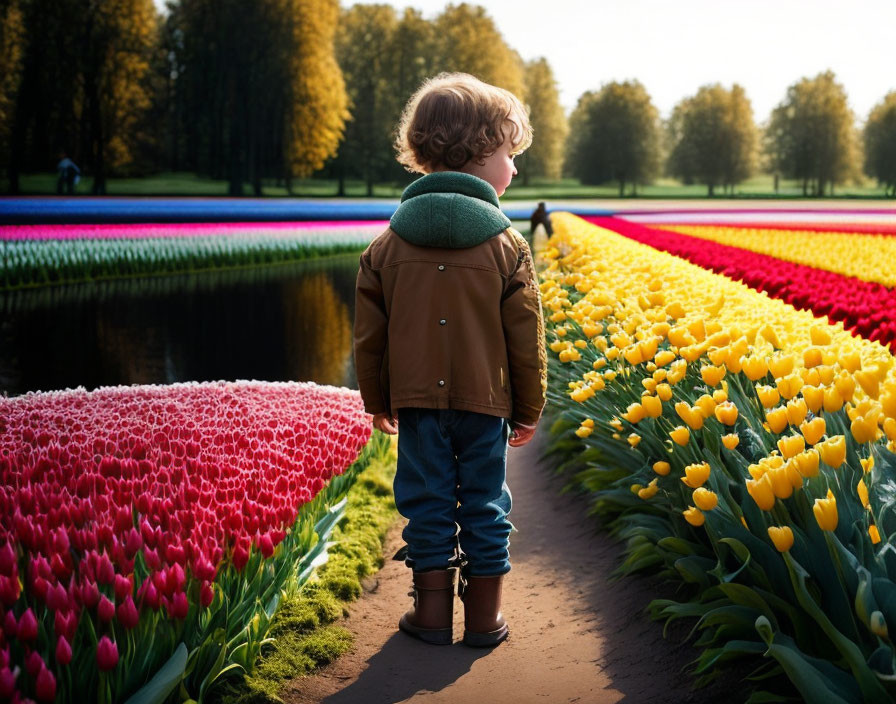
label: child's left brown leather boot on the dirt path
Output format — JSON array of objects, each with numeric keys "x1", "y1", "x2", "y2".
[{"x1": 398, "y1": 567, "x2": 457, "y2": 645}]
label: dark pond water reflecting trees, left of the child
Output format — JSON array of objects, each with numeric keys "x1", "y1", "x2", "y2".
[{"x1": 0, "y1": 254, "x2": 358, "y2": 395}]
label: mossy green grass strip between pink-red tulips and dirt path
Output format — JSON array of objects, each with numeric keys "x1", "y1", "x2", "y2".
[{"x1": 209, "y1": 432, "x2": 398, "y2": 704}]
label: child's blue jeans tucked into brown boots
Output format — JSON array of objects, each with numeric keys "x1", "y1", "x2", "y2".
[{"x1": 394, "y1": 408, "x2": 513, "y2": 576}]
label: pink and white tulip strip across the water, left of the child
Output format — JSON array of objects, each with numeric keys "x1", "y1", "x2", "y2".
[{"x1": 0, "y1": 223, "x2": 383, "y2": 290}]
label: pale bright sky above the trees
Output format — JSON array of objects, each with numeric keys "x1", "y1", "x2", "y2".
[{"x1": 155, "y1": 0, "x2": 896, "y2": 122}]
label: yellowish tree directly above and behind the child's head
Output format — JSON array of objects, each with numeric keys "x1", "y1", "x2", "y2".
[{"x1": 433, "y1": 3, "x2": 525, "y2": 96}]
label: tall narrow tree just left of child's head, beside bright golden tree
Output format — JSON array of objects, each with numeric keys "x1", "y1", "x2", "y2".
[{"x1": 336, "y1": 5, "x2": 400, "y2": 196}]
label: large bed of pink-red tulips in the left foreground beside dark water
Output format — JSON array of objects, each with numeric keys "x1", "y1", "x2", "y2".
[{"x1": 0, "y1": 382, "x2": 384, "y2": 702}]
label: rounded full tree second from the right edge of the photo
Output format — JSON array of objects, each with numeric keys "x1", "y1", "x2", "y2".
[{"x1": 766, "y1": 71, "x2": 858, "y2": 196}]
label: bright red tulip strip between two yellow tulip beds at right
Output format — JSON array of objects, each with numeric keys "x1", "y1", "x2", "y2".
[{"x1": 587, "y1": 217, "x2": 896, "y2": 352}]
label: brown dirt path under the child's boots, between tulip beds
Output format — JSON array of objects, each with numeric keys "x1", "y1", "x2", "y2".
[{"x1": 283, "y1": 428, "x2": 732, "y2": 704}]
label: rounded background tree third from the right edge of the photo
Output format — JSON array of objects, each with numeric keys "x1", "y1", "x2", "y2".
[{"x1": 667, "y1": 83, "x2": 758, "y2": 197}]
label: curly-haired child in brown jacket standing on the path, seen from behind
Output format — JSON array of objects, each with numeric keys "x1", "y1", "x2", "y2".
[{"x1": 354, "y1": 73, "x2": 546, "y2": 647}]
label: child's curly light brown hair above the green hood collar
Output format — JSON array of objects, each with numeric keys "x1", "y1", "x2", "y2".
[{"x1": 395, "y1": 73, "x2": 532, "y2": 195}]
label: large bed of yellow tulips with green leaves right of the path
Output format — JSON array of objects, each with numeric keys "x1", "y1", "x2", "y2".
[{"x1": 541, "y1": 213, "x2": 896, "y2": 704}]
